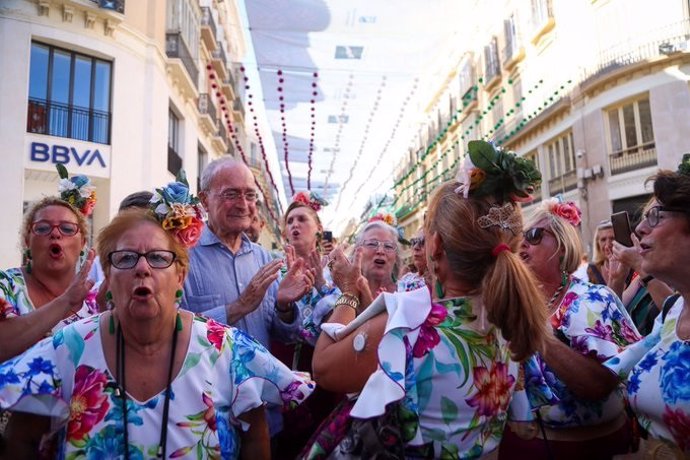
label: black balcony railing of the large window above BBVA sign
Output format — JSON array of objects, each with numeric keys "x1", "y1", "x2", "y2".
[{"x1": 26, "y1": 98, "x2": 110, "y2": 144}]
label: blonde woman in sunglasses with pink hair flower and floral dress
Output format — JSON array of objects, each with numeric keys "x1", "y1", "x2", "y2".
[{"x1": 499, "y1": 199, "x2": 640, "y2": 460}]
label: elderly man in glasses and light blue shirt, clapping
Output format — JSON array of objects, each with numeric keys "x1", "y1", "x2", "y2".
[{"x1": 182, "y1": 157, "x2": 314, "y2": 434}]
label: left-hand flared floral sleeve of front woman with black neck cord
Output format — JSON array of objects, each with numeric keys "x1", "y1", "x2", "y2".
[{"x1": 0, "y1": 337, "x2": 69, "y2": 423}]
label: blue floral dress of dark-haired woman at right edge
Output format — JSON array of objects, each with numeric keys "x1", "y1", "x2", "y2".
[{"x1": 604, "y1": 297, "x2": 690, "y2": 450}]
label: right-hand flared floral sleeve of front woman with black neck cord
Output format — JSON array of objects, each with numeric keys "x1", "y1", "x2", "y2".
[{"x1": 226, "y1": 328, "x2": 314, "y2": 417}]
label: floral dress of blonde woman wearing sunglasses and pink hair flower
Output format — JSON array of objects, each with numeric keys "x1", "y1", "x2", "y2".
[{"x1": 511, "y1": 278, "x2": 640, "y2": 428}]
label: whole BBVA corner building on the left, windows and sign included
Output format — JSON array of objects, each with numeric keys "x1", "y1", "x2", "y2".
[{"x1": 0, "y1": 0, "x2": 264, "y2": 267}]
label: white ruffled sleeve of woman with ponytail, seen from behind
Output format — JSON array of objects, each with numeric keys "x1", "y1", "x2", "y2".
[{"x1": 350, "y1": 288, "x2": 431, "y2": 418}]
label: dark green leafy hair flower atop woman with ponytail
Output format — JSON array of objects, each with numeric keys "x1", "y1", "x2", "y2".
[{"x1": 455, "y1": 141, "x2": 541, "y2": 203}]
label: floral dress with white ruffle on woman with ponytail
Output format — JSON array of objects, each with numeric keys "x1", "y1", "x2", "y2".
[{"x1": 350, "y1": 287, "x2": 518, "y2": 458}]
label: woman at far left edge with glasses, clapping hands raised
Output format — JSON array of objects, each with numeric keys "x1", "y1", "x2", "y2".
[{"x1": 0, "y1": 185, "x2": 97, "y2": 364}]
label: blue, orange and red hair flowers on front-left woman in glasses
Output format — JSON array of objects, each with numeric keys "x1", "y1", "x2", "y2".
[{"x1": 150, "y1": 170, "x2": 204, "y2": 248}]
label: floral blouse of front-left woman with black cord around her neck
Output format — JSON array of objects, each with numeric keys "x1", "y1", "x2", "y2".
[{"x1": 0, "y1": 315, "x2": 313, "y2": 459}]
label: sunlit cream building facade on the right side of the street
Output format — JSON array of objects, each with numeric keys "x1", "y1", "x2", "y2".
[{"x1": 395, "y1": 0, "x2": 690, "y2": 255}]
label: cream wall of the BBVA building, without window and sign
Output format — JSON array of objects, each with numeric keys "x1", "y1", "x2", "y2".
[{"x1": 0, "y1": 0, "x2": 253, "y2": 267}]
